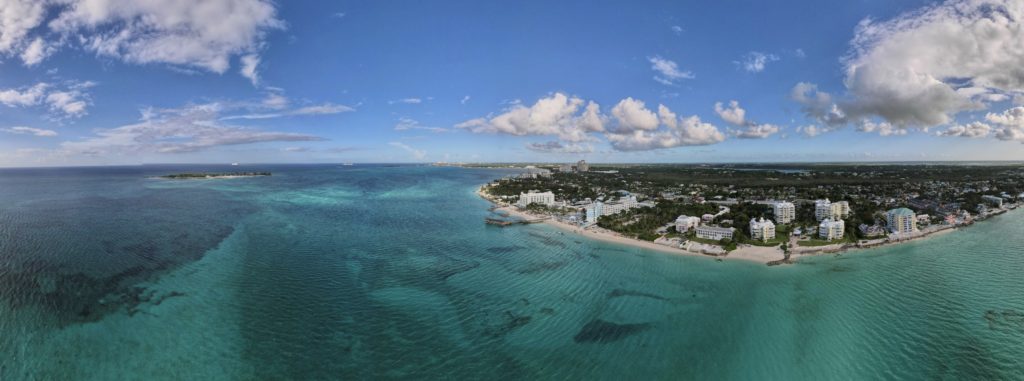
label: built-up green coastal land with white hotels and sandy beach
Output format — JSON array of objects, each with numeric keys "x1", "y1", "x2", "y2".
[{"x1": 471, "y1": 161, "x2": 1024, "y2": 265}]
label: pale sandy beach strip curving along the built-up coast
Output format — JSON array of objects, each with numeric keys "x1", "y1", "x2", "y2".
[{"x1": 476, "y1": 185, "x2": 1011, "y2": 265}]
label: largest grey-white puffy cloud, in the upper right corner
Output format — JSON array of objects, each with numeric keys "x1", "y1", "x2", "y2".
[{"x1": 794, "y1": 0, "x2": 1024, "y2": 132}]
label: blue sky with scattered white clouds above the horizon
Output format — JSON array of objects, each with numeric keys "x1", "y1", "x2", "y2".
[{"x1": 0, "y1": 0, "x2": 1024, "y2": 166}]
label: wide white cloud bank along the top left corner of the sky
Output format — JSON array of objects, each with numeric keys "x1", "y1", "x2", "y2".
[{"x1": 0, "y1": 0, "x2": 285, "y2": 79}]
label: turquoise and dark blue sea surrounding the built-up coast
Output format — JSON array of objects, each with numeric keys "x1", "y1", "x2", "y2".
[{"x1": 0, "y1": 166, "x2": 1024, "y2": 380}]
